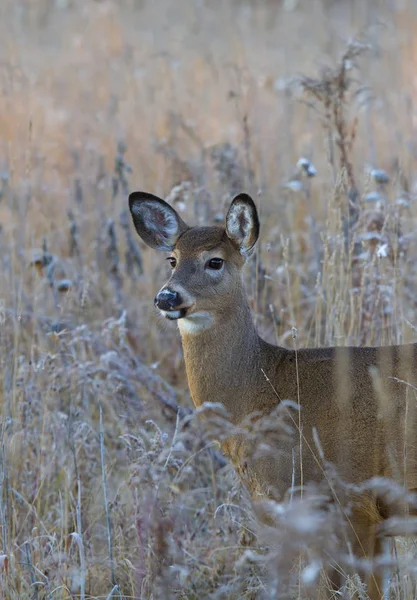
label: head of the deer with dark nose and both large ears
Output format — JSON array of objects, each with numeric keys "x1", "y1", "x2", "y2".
[{"x1": 129, "y1": 192, "x2": 259, "y2": 333}]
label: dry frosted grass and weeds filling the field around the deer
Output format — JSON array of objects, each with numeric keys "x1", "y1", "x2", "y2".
[{"x1": 0, "y1": 0, "x2": 417, "y2": 600}]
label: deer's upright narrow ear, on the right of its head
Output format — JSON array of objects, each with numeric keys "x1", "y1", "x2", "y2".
[{"x1": 226, "y1": 194, "x2": 259, "y2": 257}]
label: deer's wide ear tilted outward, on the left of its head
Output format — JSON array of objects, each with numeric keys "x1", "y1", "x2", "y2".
[{"x1": 129, "y1": 192, "x2": 189, "y2": 250}]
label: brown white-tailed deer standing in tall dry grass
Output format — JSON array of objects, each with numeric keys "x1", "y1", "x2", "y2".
[{"x1": 129, "y1": 191, "x2": 417, "y2": 600}]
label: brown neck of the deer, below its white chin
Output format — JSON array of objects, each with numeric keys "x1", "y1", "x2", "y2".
[{"x1": 178, "y1": 290, "x2": 262, "y2": 422}]
